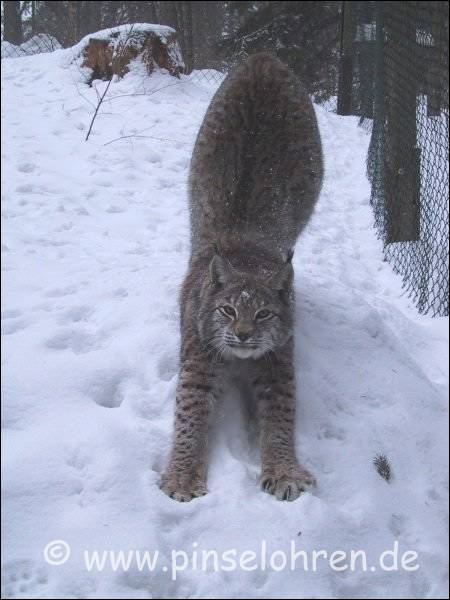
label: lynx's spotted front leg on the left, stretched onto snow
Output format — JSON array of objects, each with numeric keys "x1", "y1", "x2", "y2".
[{"x1": 161, "y1": 359, "x2": 216, "y2": 502}]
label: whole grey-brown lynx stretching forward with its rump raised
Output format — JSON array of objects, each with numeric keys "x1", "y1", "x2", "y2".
[{"x1": 161, "y1": 54, "x2": 323, "y2": 501}]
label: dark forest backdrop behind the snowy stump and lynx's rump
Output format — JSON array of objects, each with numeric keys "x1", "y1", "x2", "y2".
[{"x1": 3, "y1": 0, "x2": 341, "y2": 99}]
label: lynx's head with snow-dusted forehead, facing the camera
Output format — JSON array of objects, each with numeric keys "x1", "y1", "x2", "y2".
[{"x1": 200, "y1": 254, "x2": 293, "y2": 358}]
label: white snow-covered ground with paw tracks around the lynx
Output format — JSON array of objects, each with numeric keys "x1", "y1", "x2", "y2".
[{"x1": 2, "y1": 50, "x2": 448, "y2": 598}]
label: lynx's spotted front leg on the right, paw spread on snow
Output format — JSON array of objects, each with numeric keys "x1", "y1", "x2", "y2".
[{"x1": 254, "y1": 356, "x2": 315, "y2": 500}]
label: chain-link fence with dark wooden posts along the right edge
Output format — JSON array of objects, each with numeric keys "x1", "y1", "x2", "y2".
[{"x1": 338, "y1": 1, "x2": 449, "y2": 315}]
